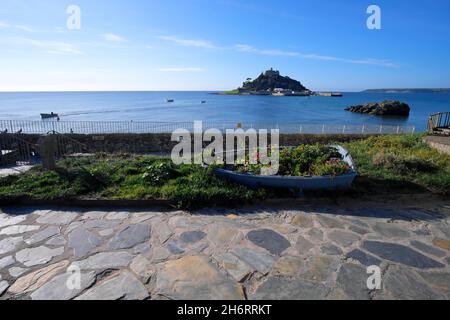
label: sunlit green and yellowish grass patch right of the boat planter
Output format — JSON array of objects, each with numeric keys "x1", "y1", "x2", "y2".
[{"x1": 343, "y1": 134, "x2": 450, "y2": 195}]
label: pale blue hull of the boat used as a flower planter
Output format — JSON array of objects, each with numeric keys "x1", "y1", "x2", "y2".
[{"x1": 214, "y1": 145, "x2": 357, "y2": 190}]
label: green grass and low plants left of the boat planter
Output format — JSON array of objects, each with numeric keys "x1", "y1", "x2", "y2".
[{"x1": 0, "y1": 154, "x2": 267, "y2": 207}]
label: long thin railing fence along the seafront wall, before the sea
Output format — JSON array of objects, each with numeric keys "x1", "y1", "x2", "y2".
[{"x1": 0, "y1": 120, "x2": 416, "y2": 134}]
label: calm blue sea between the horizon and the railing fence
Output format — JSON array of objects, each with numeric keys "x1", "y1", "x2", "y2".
[{"x1": 0, "y1": 92, "x2": 450, "y2": 130}]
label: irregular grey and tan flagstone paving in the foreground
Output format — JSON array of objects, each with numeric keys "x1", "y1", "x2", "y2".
[{"x1": 0, "y1": 204, "x2": 450, "y2": 300}]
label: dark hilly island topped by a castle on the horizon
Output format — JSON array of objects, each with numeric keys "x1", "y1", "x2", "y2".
[{"x1": 219, "y1": 69, "x2": 342, "y2": 97}]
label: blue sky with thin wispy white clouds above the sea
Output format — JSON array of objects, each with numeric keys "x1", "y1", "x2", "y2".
[{"x1": 0, "y1": 0, "x2": 450, "y2": 91}]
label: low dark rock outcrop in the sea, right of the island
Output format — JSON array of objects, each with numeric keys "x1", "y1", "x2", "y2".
[{"x1": 345, "y1": 101, "x2": 411, "y2": 117}]
